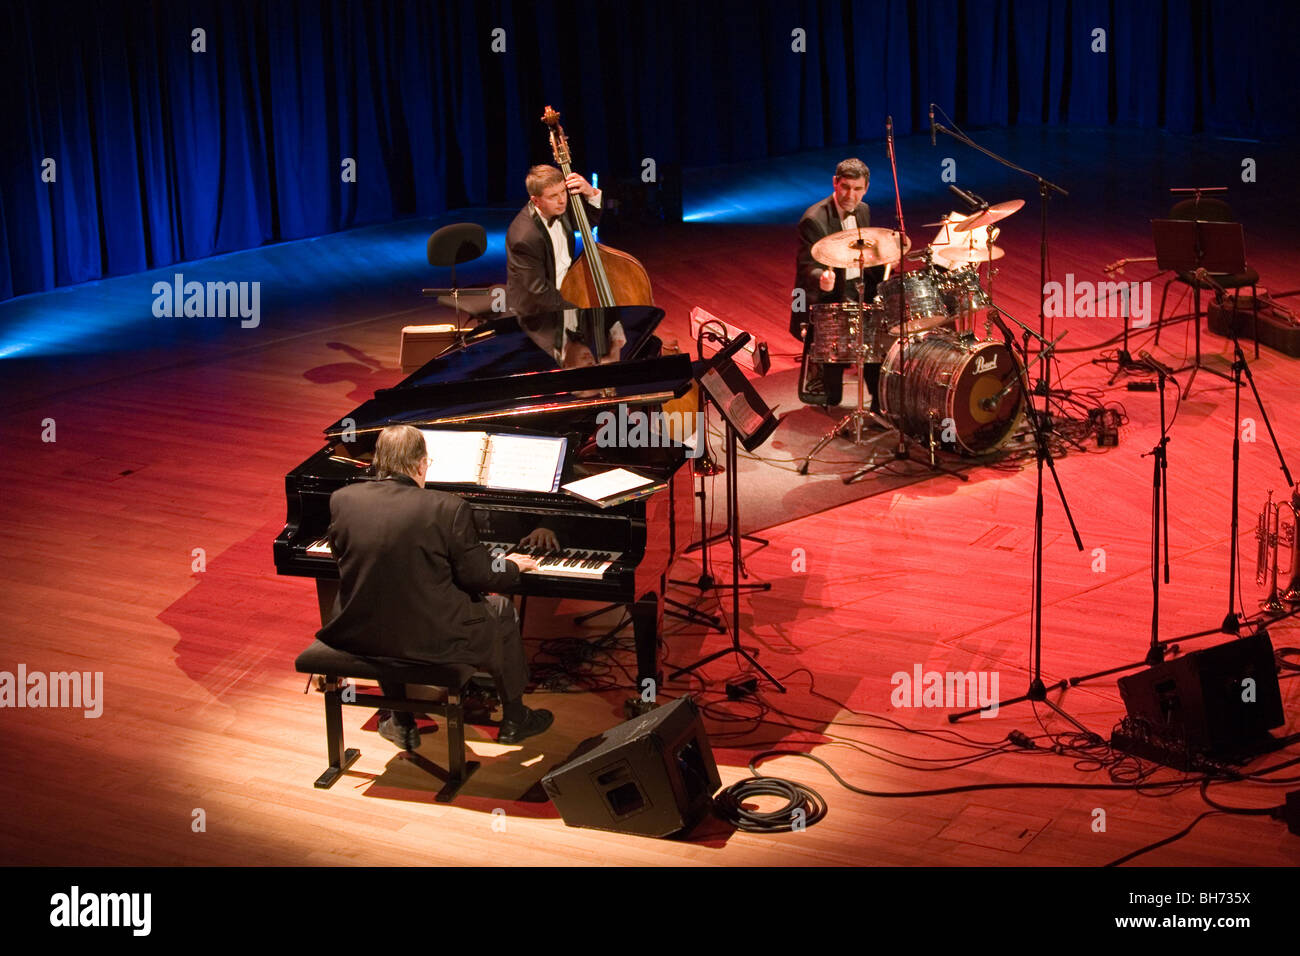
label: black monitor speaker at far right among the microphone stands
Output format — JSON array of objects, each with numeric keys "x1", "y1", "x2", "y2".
[{"x1": 1119, "y1": 633, "x2": 1283, "y2": 758}]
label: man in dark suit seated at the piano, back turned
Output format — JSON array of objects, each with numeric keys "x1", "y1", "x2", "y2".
[{"x1": 317, "y1": 425, "x2": 553, "y2": 750}]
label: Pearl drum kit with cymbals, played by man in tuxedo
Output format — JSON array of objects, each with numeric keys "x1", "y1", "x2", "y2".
[{"x1": 800, "y1": 199, "x2": 1024, "y2": 473}]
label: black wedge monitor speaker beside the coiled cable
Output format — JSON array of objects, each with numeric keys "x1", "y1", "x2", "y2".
[{"x1": 542, "y1": 697, "x2": 722, "y2": 836}]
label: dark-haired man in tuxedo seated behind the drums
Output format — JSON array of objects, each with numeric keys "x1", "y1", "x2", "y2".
[{"x1": 790, "y1": 159, "x2": 884, "y2": 411}]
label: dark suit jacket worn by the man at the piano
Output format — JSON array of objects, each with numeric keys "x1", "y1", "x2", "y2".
[{"x1": 316, "y1": 475, "x2": 519, "y2": 663}]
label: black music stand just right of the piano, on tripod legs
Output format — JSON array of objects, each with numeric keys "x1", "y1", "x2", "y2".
[{"x1": 668, "y1": 333, "x2": 785, "y2": 693}]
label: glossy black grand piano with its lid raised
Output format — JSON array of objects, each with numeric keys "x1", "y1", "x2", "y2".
[{"x1": 274, "y1": 306, "x2": 693, "y2": 704}]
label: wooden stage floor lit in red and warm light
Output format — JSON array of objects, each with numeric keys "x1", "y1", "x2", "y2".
[{"x1": 0, "y1": 130, "x2": 1300, "y2": 866}]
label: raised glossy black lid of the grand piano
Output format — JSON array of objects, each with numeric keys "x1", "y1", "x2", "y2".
[{"x1": 325, "y1": 306, "x2": 692, "y2": 437}]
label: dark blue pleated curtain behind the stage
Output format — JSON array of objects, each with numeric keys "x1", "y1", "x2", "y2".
[{"x1": 0, "y1": 0, "x2": 1300, "y2": 299}]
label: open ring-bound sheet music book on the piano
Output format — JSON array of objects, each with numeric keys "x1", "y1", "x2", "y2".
[{"x1": 421, "y1": 428, "x2": 568, "y2": 492}]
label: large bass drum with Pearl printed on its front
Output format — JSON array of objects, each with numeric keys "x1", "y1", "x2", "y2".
[{"x1": 880, "y1": 333, "x2": 1024, "y2": 455}]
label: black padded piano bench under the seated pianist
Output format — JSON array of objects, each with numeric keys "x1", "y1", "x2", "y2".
[{"x1": 294, "y1": 640, "x2": 478, "y2": 803}]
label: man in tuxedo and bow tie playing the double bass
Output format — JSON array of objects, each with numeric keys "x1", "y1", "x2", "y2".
[{"x1": 506, "y1": 165, "x2": 601, "y2": 315}]
